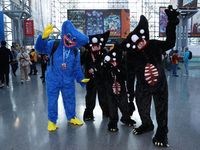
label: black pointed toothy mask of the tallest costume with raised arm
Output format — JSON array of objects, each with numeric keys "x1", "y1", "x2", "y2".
[{"x1": 119, "y1": 15, "x2": 149, "y2": 52}]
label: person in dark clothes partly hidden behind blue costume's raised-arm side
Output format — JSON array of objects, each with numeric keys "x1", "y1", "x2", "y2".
[{"x1": 40, "y1": 54, "x2": 49, "y2": 83}]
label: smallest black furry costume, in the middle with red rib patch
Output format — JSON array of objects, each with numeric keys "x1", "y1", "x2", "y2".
[{"x1": 104, "y1": 47, "x2": 136, "y2": 131}]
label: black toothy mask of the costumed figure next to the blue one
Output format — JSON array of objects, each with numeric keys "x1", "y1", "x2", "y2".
[{"x1": 84, "y1": 31, "x2": 110, "y2": 53}]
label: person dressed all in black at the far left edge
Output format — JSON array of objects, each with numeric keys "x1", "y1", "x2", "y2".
[{"x1": 0, "y1": 41, "x2": 13, "y2": 88}]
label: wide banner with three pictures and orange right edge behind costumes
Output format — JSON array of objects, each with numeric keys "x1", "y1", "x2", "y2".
[{"x1": 68, "y1": 9, "x2": 130, "y2": 44}]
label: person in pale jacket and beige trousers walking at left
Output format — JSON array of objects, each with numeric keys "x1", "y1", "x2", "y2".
[{"x1": 17, "y1": 47, "x2": 30, "y2": 83}]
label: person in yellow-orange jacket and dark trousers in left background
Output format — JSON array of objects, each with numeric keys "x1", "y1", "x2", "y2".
[{"x1": 29, "y1": 49, "x2": 38, "y2": 75}]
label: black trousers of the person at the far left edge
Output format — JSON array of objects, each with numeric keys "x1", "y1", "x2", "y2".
[{"x1": 0, "y1": 64, "x2": 9, "y2": 85}]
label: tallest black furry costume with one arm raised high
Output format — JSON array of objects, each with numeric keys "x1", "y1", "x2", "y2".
[{"x1": 119, "y1": 5, "x2": 179, "y2": 147}]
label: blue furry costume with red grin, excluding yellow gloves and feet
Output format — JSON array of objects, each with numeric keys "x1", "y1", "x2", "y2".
[{"x1": 35, "y1": 21, "x2": 89, "y2": 129}]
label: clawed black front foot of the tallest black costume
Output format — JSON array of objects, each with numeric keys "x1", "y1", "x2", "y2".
[{"x1": 153, "y1": 133, "x2": 169, "y2": 147}]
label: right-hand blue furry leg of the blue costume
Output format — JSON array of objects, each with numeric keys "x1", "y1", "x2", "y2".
[{"x1": 61, "y1": 82, "x2": 76, "y2": 121}]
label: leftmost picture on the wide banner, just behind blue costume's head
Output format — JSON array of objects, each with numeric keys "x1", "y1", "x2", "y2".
[{"x1": 68, "y1": 10, "x2": 86, "y2": 34}]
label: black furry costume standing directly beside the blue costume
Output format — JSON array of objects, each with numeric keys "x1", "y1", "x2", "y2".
[{"x1": 81, "y1": 31, "x2": 110, "y2": 121}]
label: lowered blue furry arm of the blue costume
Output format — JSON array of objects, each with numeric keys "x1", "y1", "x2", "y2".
[{"x1": 73, "y1": 48, "x2": 86, "y2": 87}]
